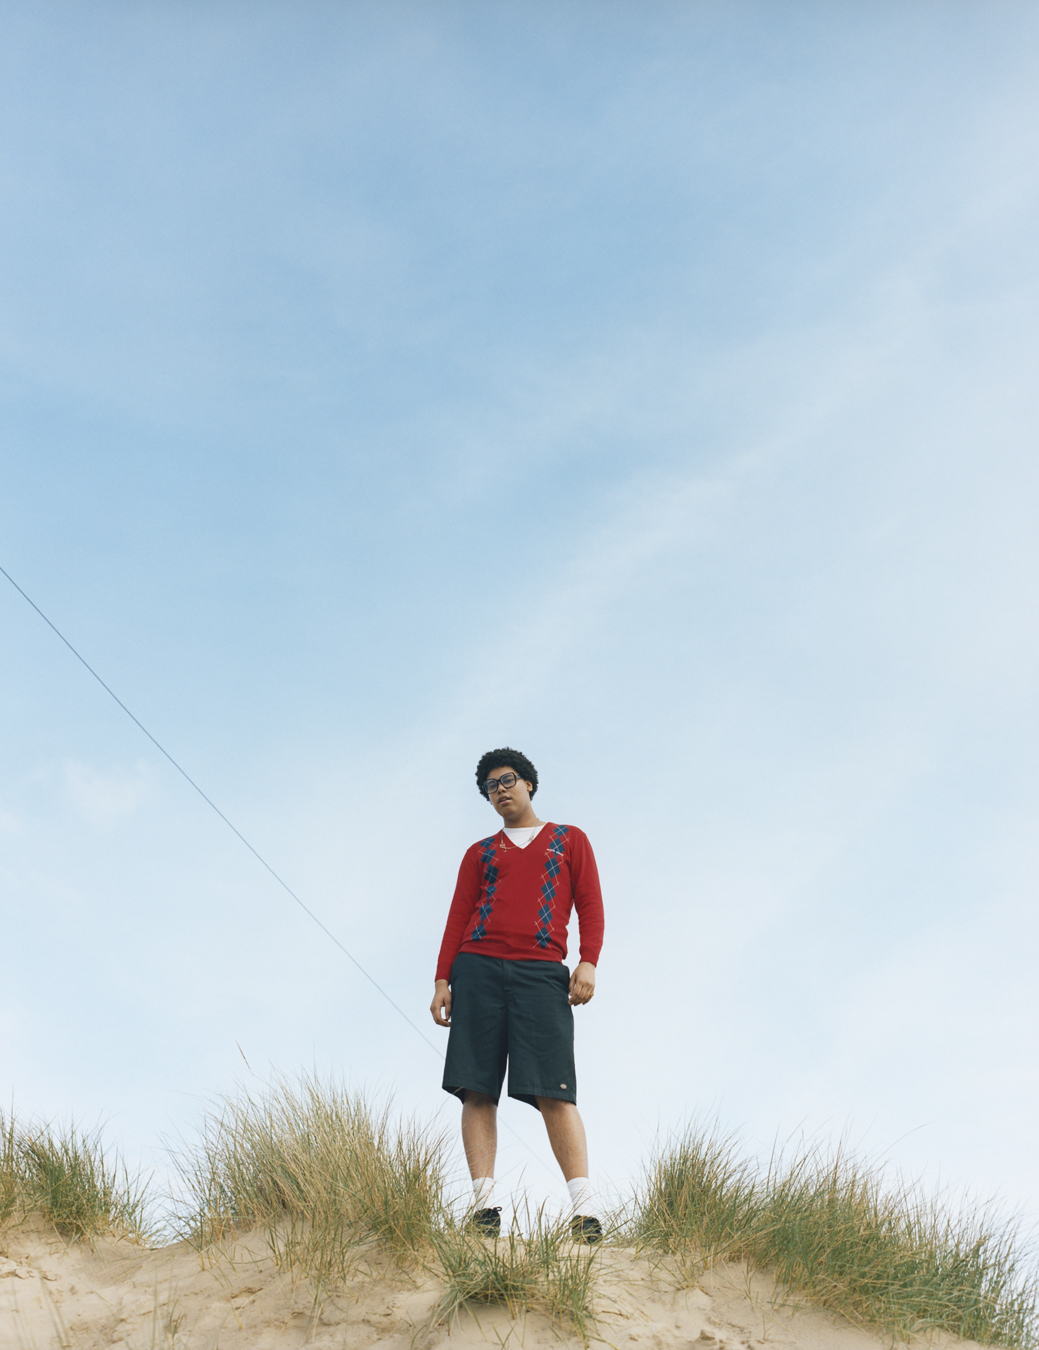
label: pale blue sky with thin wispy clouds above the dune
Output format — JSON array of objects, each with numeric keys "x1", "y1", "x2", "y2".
[{"x1": 0, "y1": 0, "x2": 1039, "y2": 1215}]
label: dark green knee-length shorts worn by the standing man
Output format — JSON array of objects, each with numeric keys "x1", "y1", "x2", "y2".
[{"x1": 444, "y1": 952, "x2": 578, "y2": 1107}]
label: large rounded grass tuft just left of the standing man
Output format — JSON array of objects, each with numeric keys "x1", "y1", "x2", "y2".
[{"x1": 179, "y1": 1077, "x2": 444, "y2": 1284}]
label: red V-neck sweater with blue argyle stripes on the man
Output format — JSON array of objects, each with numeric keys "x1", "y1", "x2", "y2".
[{"x1": 436, "y1": 822, "x2": 603, "y2": 980}]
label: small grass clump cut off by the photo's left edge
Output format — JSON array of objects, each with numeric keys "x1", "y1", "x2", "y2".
[{"x1": 0, "y1": 1114, "x2": 151, "y2": 1242}]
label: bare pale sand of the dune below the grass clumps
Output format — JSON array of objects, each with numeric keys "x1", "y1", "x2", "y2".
[{"x1": 0, "y1": 1229, "x2": 973, "y2": 1350}]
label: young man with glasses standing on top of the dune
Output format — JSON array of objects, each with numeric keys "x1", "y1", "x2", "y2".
[{"x1": 429, "y1": 747, "x2": 603, "y2": 1242}]
